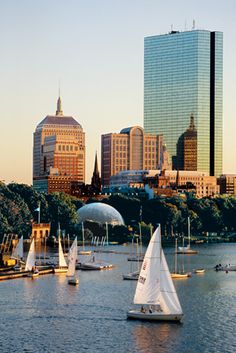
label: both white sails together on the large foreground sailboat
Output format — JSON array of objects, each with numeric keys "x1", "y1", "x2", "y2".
[{"x1": 134, "y1": 226, "x2": 182, "y2": 314}]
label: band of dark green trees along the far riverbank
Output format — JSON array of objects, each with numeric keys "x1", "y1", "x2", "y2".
[{"x1": 0, "y1": 183, "x2": 236, "y2": 238}]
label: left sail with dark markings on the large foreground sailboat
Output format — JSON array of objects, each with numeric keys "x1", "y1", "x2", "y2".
[{"x1": 134, "y1": 226, "x2": 161, "y2": 304}]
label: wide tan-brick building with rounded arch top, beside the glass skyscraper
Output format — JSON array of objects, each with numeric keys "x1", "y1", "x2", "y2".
[{"x1": 101, "y1": 126, "x2": 163, "y2": 186}]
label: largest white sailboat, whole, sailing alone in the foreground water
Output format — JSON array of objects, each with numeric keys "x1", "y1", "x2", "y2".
[{"x1": 127, "y1": 225, "x2": 183, "y2": 321}]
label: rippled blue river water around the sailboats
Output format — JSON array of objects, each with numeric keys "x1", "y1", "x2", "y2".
[{"x1": 0, "y1": 244, "x2": 236, "y2": 353}]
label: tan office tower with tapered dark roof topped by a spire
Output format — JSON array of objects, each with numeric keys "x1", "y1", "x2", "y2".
[{"x1": 33, "y1": 97, "x2": 85, "y2": 193}]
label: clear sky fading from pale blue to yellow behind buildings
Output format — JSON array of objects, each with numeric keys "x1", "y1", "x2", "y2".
[{"x1": 0, "y1": 0, "x2": 236, "y2": 185}]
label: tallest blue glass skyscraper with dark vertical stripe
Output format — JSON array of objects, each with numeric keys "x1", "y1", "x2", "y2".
[{"x1": 144, "y1": 30, "x2": 223, "y2": 176}]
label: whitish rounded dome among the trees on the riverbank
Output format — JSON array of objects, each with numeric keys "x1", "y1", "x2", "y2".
[{"x1": 77, "y1": 202, "x2": 124, "y2": 226}]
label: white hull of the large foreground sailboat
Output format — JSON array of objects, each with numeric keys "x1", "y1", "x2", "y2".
[{"x1": 127, "y1": 310, "x2": 183, "y2": 322}]
